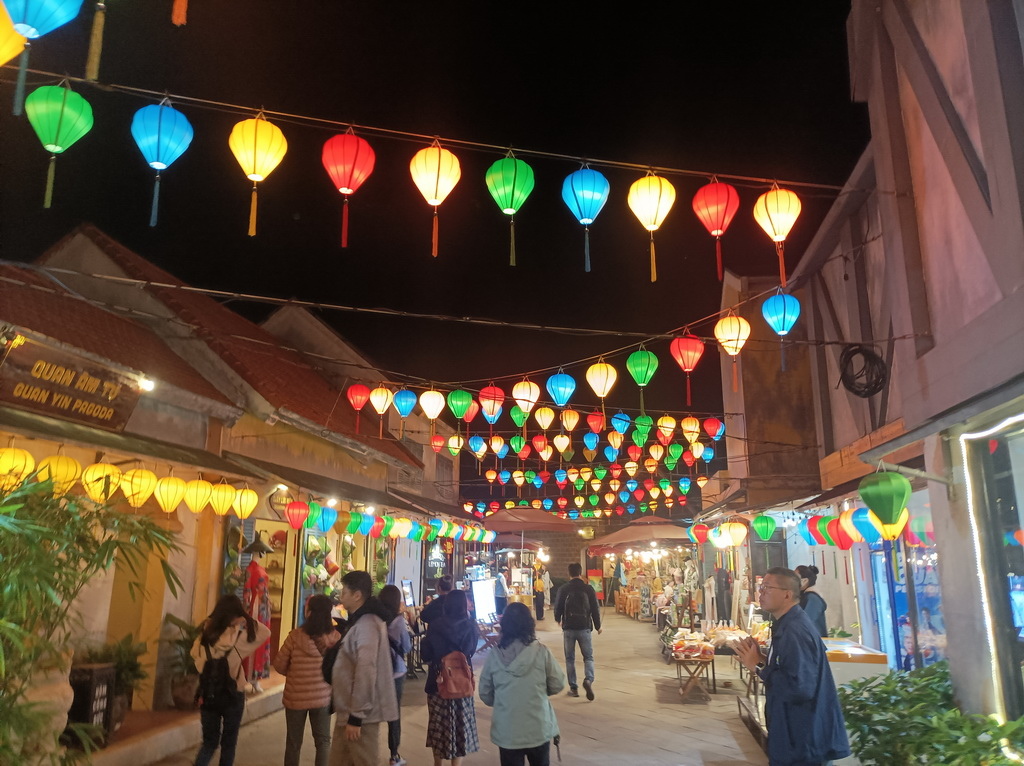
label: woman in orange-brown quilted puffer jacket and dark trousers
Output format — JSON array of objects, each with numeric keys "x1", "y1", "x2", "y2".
[{"x1": 273, "y1": 594, "x2": 341, "y2": 766}]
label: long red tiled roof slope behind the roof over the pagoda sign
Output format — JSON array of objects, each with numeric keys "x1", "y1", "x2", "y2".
[{"x1": 44, "y1": 225, "x2": 422, "y2": 468}]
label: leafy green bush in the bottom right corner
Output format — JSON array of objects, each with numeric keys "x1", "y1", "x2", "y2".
[{"x1": 839, "y1": 663, "x2": 1024, "y2": 766}]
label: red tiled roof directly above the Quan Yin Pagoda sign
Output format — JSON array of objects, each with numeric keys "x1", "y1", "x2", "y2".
[{"x1": 0, "y1": 265, "x2": 230, "y2": 403}]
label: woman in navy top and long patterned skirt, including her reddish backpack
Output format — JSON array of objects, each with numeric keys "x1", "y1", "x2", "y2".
[{"x1": 420, "y1": 591, "x2": 480, "y2": 766}]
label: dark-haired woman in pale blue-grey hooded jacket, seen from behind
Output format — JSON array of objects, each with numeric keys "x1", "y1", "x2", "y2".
[{"x1": 480, "y1": 603, "x2": 565, "y2": 766}]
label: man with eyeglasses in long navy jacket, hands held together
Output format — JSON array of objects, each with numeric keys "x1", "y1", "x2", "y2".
[{"x1": 733, "y1": 566, "x2": 850, "y2": 766}]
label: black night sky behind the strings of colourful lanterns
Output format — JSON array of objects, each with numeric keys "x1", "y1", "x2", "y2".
[{"x1": 0, "y1": 0, "x2": 867, "y2": 430}]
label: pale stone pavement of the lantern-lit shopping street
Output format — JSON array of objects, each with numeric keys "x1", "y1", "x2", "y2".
[{"x1": 148, "y1": 609, "x2": 768, "y2": 766}]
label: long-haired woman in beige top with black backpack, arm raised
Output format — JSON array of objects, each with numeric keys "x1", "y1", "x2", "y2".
[{"x1": 191, "y1": 595, "x2": 270, "y2": 766}]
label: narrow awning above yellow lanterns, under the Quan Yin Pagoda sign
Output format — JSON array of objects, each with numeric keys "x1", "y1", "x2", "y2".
[{"x1": 0, "y1": 408, "x2": 254, "y2": 478}]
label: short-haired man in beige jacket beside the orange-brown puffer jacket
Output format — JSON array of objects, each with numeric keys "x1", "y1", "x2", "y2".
[{"x1": 330, "y1": 570, "x2": 398, "y2": 766}]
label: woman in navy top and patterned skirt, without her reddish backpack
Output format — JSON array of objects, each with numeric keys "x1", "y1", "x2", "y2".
[{"x1": 420, "y1": 591, "x2": 480, "y2": 766}]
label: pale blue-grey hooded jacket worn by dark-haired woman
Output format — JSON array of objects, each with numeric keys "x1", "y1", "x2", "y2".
[{"x1": 479, "y1": 641, "x2": 565, "y2": 750}]
